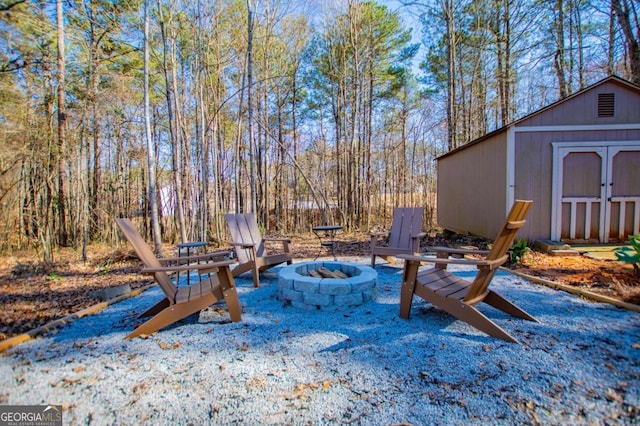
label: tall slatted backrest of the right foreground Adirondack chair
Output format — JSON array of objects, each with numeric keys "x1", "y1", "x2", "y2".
[{"x1": 464, "y1": 200, "x2": 533, "y2": 303}]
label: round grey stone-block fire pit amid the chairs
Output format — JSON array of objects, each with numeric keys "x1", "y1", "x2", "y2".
[{"x1": 278, "y1": 261, "x2": 378, "y2": 310}]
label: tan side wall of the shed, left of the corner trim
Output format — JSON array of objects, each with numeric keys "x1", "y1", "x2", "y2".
[{"x1": 438, "y1": 133, "x2": 507, "y2": 238}]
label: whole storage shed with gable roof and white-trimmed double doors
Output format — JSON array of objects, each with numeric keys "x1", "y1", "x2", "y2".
[{"x1": 437, "y1": 76, "x2": 640, "y2": 243}]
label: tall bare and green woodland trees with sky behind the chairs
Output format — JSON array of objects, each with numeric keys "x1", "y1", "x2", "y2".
[{"x1": 0, "y1": 0, "x2": 640, "y2": 260}]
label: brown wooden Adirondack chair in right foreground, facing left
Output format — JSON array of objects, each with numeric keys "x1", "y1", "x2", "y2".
[{"x1": 398, "y1": 200, "x2": 537, "y2": 343}]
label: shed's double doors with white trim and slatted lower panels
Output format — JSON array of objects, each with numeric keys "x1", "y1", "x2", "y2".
[{"x1": 552, "y1": 146, "x2": 640, "y2": 243}]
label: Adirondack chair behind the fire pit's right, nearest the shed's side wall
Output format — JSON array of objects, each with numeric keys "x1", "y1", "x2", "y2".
[{"x1": 371, "y1": 207, "x2": 426, "y2": 268}]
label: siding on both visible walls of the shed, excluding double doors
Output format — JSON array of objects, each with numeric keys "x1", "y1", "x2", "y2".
[{"x1": 437, "y1": 77, "x2": 640, "y2": 241}]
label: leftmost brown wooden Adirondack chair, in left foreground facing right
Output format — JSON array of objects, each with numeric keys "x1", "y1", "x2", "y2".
[{"x1": 116, "y1": 219, "x2": 241, "y2": 339}]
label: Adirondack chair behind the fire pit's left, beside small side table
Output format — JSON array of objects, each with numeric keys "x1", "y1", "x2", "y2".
[{"x1": 225, "y1": 213, "x2": 293, "y2": 287}]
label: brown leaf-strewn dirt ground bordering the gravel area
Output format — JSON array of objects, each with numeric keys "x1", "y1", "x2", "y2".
[{"x1": 0, "y1": 233, "x2": 640, "y2": 340}]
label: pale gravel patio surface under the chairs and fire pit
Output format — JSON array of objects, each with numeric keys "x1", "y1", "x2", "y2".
[{"x1": 0, "y1": 258, "x2": 640, "y2": 425}]
